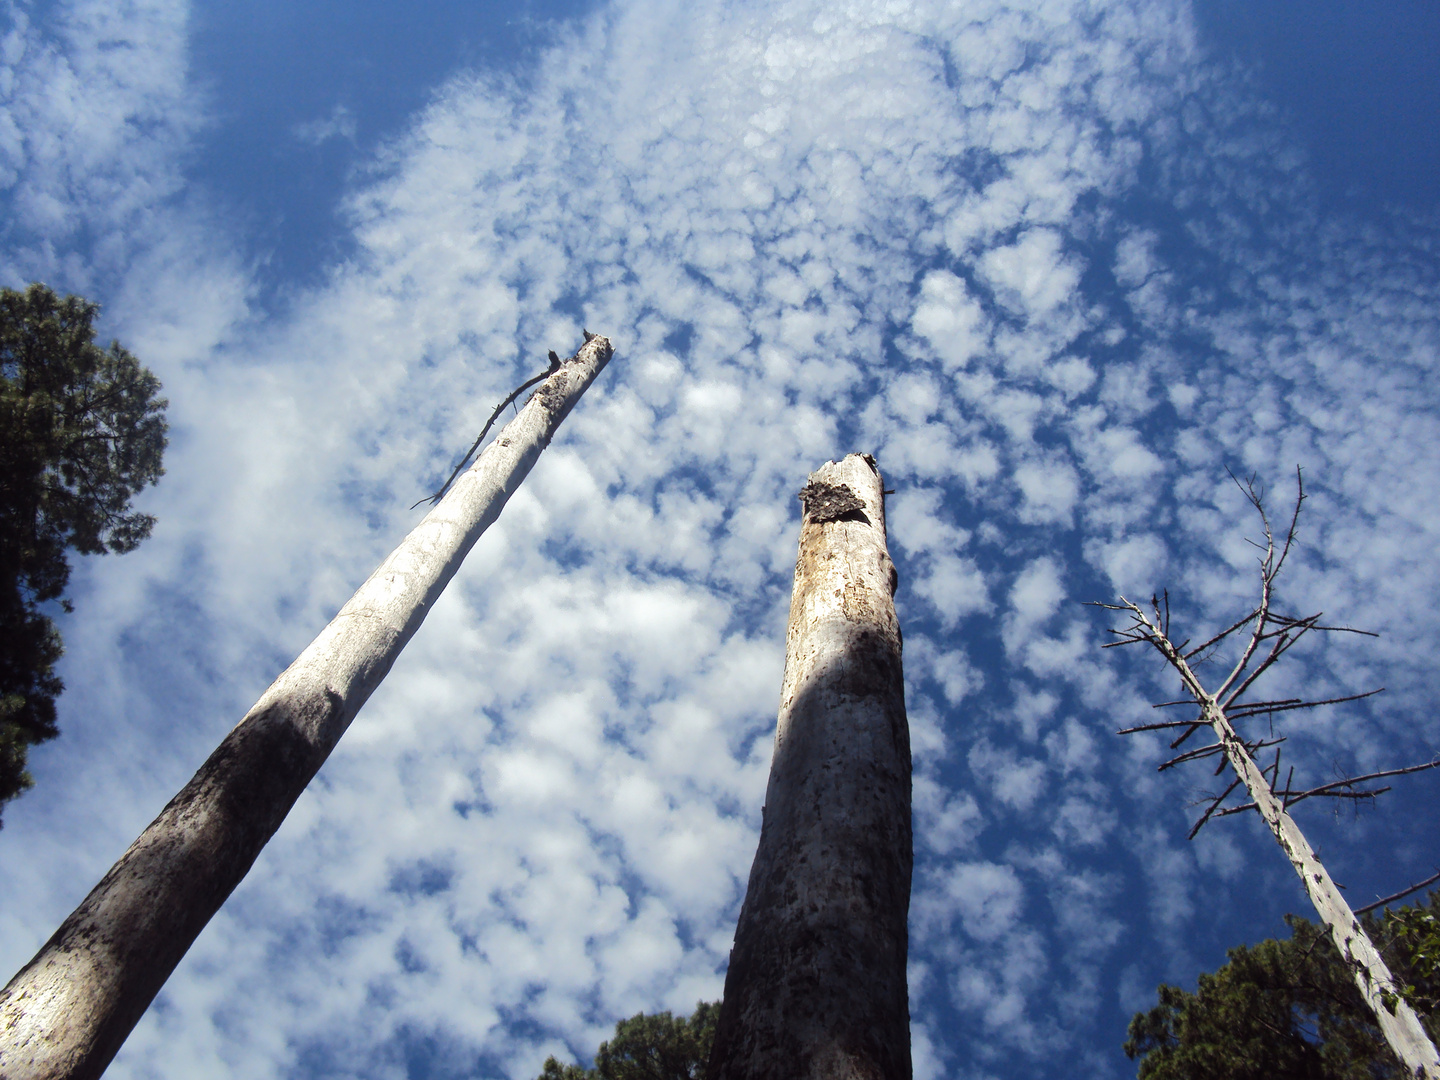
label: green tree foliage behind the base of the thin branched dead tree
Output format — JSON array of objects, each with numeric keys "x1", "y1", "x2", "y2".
[{"x1": 1125, "y1": 891, "x2": 1440, "y2": 1080}]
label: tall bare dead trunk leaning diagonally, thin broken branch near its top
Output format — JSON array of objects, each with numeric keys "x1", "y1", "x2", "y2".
[{"x1": 0, "y1": 337, "x2": 612, "y2": 1080}]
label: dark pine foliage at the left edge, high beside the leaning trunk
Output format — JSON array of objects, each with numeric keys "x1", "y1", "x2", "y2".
[{"x1": 0, "y1": 285, "x2": 167, "y2": 823}]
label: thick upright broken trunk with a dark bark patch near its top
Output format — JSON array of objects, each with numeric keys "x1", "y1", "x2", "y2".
[{"x1": 708, "y1": 454, "x2": 912, "y2": 1080}]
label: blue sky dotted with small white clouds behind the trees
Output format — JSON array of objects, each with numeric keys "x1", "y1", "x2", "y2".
[{"x1": 0, "y1": 0, "x2": 1440, "y2": 1080}]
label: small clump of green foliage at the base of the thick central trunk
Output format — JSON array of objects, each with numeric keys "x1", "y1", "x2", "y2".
[{"x1": 539, "y1": 1001, "x2": 720, "y2": 1080}]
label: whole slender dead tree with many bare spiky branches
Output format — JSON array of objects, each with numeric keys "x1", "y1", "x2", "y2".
[{"x1": 1094, "y1": 469, "x2": 1440, "y2": 1080}]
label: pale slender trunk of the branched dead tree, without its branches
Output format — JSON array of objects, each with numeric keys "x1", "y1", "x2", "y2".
[{"x1": 1158, "y1": 634, "x2": 1440, "y2": 1080}]
